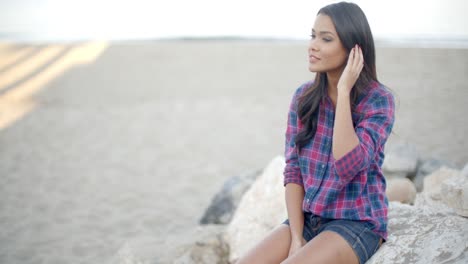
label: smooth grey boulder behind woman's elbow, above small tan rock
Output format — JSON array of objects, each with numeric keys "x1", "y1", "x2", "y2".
[{"x1": 382, "y1": 143, "x2": 419, "y2": 178}]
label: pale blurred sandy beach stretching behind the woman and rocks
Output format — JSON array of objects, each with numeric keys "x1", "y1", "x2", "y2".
[{"x1": 0, "y1": 40, "x2": 468, "y2": 263}]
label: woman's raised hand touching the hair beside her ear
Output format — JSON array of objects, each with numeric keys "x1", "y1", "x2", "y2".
[{"x1": 337, "y1": 44, "x2": 364, "y2": 95}]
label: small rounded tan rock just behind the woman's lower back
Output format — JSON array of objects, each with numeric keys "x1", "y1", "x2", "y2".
[{"x1": 386, "y1": 178, "x2": 416, "y2": 204}]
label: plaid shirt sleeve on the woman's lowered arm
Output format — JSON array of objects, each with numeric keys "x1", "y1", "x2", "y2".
[{"x1": 283, "y1": 87, "x2": 304, "y2": 186}]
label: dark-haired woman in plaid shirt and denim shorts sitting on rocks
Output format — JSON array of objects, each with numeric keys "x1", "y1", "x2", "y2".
[{"x1": 237, "y1": 2, "x2": 394, "y2": 264}]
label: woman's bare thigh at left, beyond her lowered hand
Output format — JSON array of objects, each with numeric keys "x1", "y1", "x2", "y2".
[{"x1": 235, "y1": 224, "x2": 291, "y2": 264}]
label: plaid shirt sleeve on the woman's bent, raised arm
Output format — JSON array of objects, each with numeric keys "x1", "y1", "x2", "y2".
[{"x1": 334, "y1": 93, "x2": 395, "y2": 182}]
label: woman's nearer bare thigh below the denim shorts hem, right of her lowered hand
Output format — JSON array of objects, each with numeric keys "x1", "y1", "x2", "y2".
[{"x1": 282, "y1": 231, "x2": 359, "y2": 264}]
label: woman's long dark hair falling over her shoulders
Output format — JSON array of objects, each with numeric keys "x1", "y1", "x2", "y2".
[{"x1": 295, "y1": 2, "x2": 377, "y2": 151}]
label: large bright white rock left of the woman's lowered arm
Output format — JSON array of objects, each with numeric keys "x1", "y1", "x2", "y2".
[{"x1": 225, "y1": 156, "x2": 287, "y2": 263}]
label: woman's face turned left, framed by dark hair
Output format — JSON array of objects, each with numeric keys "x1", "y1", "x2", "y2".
[{"x1": 308, "y1": 14, "x2": 348, "y2": 73}]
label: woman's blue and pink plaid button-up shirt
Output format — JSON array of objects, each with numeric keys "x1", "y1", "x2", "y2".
[{"x1": 284, "y1": 82, "x2": 395, "y2": 240}]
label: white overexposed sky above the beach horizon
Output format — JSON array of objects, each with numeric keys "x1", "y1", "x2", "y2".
[{"x1": 0, "y1": 0, "x2": 468, "y2": 40}]
